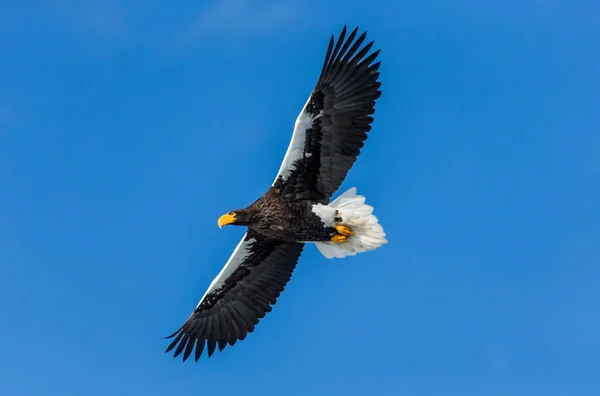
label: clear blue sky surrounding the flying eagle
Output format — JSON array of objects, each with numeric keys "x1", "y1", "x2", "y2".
[{"x1": 0, "y1": 0, "x2": 600, "y2": 396}]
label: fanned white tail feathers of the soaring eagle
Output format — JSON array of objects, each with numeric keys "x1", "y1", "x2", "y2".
[{"x1": 316, "y1": 187, "x2": 387, "y2": 258}]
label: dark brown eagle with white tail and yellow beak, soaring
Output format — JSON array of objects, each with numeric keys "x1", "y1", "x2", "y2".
[{"x1": 166, "y1": 26, "x2": 387, "y2": 361}]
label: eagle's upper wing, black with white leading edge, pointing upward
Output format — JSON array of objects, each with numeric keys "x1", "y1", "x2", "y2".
[{"x1": 273, "y1": 27, "x2": 381, "y2": 203}]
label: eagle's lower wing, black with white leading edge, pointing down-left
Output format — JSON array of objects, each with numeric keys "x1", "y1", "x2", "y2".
[{"x1": 166, "y1": 230, "x2": 304, "y2": 361}]
